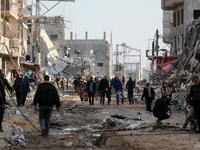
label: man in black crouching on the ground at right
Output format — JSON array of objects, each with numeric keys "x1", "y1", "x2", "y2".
[{"x1": 153, "y1": 96, "x2": 170, "y2": 125}]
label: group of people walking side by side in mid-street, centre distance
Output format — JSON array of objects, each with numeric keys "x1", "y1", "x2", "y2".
[{"x1": 74, "y1": 76, "x2": 135, "y2": 105}]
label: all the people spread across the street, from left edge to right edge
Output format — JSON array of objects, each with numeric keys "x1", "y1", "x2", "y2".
[{"x1": 0, "y1": 71, "x2": 200, "y2": 136}]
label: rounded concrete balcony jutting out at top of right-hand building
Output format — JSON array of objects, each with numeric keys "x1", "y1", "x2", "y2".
[{"x1": 161, "y1": 0, "x2": 184, "y2": 10}]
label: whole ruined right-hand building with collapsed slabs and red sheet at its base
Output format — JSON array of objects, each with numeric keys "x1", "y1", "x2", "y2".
[{"x1": 147, "y1": 0, "x2": 200, "y2": 80}]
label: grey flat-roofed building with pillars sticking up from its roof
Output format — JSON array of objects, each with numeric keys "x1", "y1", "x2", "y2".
[{"x1": 64, "y1": 32, "x2": 113, "y2": 78}]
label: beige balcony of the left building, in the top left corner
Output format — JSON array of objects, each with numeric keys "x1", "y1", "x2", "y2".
[{"x1": 1, "y1": 0, "x2": 19, "y2": 20}]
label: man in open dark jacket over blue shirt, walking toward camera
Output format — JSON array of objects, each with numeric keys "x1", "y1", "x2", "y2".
[{"x1": 87, "y1": 76, "x2": 96, "y2": 105}]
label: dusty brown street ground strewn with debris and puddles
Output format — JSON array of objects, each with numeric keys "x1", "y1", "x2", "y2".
[{"x1": 4, "y1": 92, "x2": 200, "y2": 150}]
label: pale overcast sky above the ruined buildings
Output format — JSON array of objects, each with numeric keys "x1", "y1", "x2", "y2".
[{"x1": 28, "y1": 0, "x2": 165, "y2": 67}]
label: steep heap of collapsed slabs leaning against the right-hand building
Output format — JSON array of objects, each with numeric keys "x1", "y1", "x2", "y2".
[{"x1": 172, "y1": 17, "x2": 200, "y2": 74}]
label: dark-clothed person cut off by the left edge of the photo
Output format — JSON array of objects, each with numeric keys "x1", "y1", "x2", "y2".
[{"x1": 0, "y1": 71, "x2": 12, "y2": 132}]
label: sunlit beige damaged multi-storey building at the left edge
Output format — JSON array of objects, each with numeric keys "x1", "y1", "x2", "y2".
[{"x1": 0, "y1": 0, "x2": 27, "y2": 80}]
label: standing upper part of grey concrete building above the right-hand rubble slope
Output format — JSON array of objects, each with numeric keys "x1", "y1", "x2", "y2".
[{"x1": 161, "y1": 0, "x2": 200, "y2": 55}]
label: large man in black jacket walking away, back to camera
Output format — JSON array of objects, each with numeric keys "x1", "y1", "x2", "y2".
[{"x1": 33, "y1": 75, "x2": 60, "y2": 136}]
